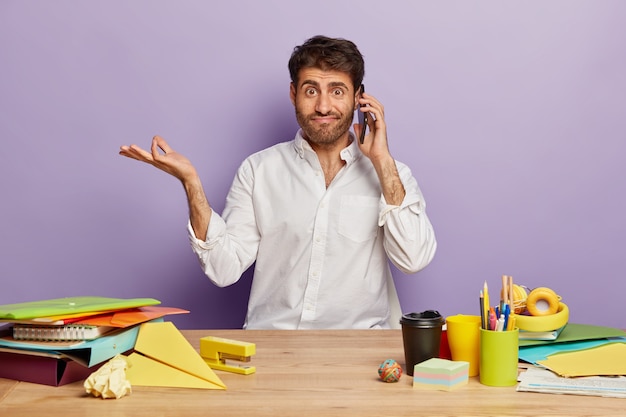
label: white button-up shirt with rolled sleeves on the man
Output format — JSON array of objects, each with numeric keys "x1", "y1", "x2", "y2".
[{"x1": 187, "y1": 132, "x2": 437, "y2": 329}]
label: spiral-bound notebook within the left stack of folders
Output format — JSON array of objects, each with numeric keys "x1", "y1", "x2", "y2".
[{"x1": 13, "y1": 324, "x2": 115, "y2": 342}]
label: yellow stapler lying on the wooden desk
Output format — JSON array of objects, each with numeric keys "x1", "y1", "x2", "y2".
[{"x1": 200, "y1": 336, "x2": 256, "y2": 375}]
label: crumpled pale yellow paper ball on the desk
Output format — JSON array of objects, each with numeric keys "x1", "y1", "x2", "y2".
[{"x1": 83, "y1": 355, "x2": 132, "y2": 399}]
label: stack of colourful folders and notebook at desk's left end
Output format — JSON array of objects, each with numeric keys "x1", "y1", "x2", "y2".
[{"x1": 0, "y1": 296, "x2": 188, "y2": 386}]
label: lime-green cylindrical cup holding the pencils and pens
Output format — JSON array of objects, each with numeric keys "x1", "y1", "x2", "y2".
[{"x1": 480, "y1": 329, "x2": 519, "y2": 387}]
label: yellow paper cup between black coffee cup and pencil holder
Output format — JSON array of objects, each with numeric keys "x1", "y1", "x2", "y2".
[{"x1": 446, "y1": 314, "x2": 480, "y2": 376}]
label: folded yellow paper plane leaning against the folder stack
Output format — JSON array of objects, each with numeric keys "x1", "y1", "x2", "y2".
[{"x1": 126, "y1": 322, "x2": 226, "y2": 389}]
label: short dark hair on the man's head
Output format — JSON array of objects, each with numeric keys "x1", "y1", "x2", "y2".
[{"x1": 289, "y1": 35, "x2": 365, "y2": 90}]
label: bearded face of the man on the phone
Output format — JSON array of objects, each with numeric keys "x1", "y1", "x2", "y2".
[{"x1": 290, "y1": 68, "x2": 355, "y2": 147}]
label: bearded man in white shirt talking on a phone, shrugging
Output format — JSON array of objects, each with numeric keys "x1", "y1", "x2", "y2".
[{"x1": 120, "y1": 36, "x2": 436, "y2": 329}]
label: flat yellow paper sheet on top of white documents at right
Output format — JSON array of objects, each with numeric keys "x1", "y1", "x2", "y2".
[{"x1": 537, "y1": 343, "x2": 626, "y2": 377}]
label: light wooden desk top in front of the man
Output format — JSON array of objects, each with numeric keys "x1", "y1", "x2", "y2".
[{"x1": 0, "y1": 330, "x2": 626, "y2": 417}]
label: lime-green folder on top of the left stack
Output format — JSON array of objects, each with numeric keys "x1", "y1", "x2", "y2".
[{"x1": 0, "y1": 296, "x2": 161, "y2": 321}]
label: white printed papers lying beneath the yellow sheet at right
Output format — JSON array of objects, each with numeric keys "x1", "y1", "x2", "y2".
[{"x1": 517, "y1": 367, "x2": 626, "y2": 398}]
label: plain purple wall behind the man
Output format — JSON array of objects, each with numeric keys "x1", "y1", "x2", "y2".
[{"x1": 0, "y1": 0, "x2": 626, "y2": 328}]
